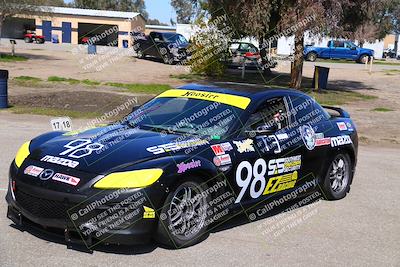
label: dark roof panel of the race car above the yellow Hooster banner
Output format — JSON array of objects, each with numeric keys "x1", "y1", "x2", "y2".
[{"x1": 178, "y1": 83, "x2": 310, "y2": 101}]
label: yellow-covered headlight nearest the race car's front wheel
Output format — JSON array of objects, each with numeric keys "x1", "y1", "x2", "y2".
[{"x1": 94, "y1": 169, "x2": 163, "y2": 189}]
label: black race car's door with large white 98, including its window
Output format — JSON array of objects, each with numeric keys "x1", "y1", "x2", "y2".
[{"x1": 232, "y1": 95, "x2": 301, "y2": 205}]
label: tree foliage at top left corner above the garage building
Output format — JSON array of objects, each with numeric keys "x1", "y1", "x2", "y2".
[{"x1": 0, "y1": 0, "x2": 47, "y2": 44}]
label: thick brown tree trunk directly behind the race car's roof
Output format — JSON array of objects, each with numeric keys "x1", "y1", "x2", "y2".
[{"x1": 290, "y1": 32, "x2": 304, "y2": 89}]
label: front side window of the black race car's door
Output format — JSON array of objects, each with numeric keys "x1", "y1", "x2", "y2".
[{"x1": 245, "y1": 97, "x2": 289, "y2": 131}]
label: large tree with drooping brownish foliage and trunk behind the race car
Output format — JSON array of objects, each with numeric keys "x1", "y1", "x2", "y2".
[{"x1": 207, "y1": 0, "x2": 399, "y2": 89}]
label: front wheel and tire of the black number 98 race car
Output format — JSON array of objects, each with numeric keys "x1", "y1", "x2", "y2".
[{"x1": 154, "y1": 177, "x2": 210, "y2": 249}]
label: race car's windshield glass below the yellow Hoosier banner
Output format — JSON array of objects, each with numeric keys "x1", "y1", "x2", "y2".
[{"x1": 127, "y1": 97, "x2": 243, "y2": 137}]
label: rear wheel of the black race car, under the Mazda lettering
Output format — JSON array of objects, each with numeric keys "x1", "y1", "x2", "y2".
[{"x1": 320, "y1": 153, "x2": 353, "y2": 200}]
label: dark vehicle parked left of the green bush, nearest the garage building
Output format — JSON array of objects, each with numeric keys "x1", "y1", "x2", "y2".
[{"x1": 133, "y1": 32, "x2": 190, "y2": 64}]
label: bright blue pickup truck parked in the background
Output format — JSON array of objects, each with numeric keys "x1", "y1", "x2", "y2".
[{"x1": 304, "y1": 40, "x2": 374, "y2": 63}]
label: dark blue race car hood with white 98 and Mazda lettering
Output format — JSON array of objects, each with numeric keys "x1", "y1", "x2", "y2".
[{"x1": 30, "y1": 125, "x2": 208, "y2": 174}]
